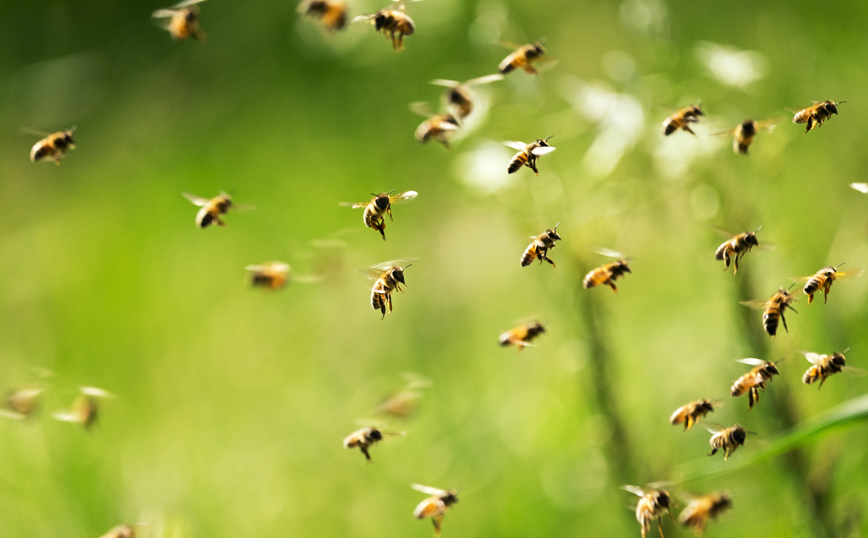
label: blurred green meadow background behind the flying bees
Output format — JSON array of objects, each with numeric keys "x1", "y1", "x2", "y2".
[{"x1": 0, "y1": 0, "x2": 868, "y2": 538}]
